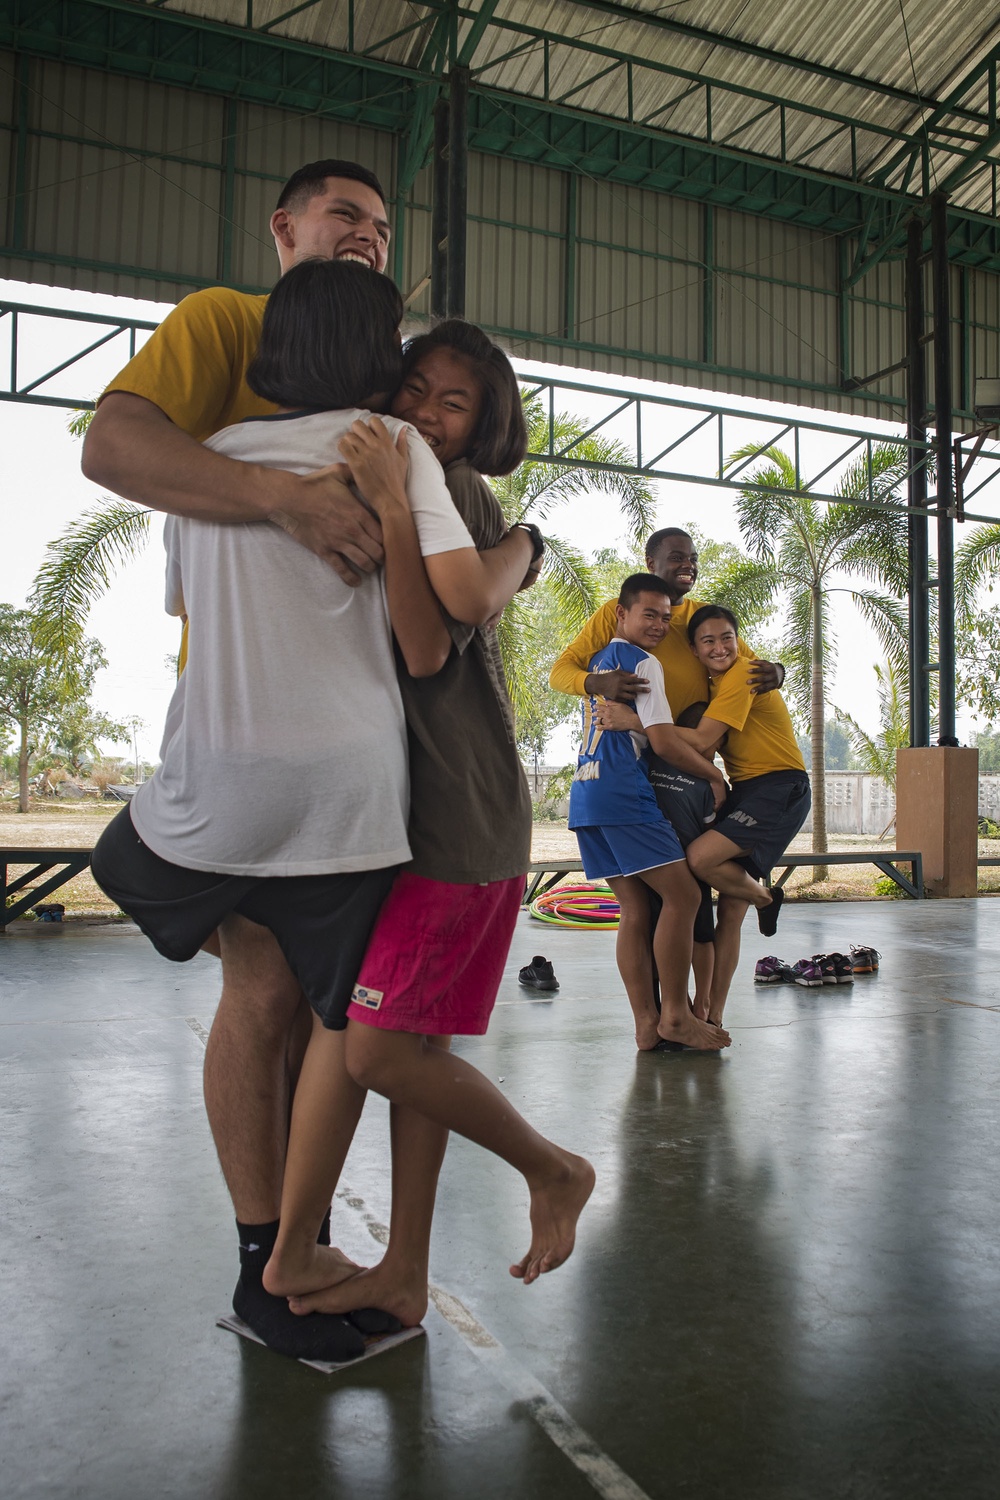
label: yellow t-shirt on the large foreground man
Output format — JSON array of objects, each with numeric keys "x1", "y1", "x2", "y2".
[{"x1": 103, "y1": 287, "x2": 277, "y2": 443}]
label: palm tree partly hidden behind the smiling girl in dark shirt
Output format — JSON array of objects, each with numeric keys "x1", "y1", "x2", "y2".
[{"x1": 490, "y1": 396, "x2": 655, "y2": 719}]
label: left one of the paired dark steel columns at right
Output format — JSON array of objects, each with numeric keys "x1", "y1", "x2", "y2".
[{"x1": 906, "y1": 218, "x2": 931, "y2": 746}]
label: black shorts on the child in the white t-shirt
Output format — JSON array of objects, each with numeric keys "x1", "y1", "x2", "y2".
[{"x1": 90, "y1": 807, "x2": 399, "y2": 1031}]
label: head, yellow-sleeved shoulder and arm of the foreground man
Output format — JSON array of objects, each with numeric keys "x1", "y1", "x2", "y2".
[{"x1": 82, "y1": 161, "x2": 390, "y2": 584}]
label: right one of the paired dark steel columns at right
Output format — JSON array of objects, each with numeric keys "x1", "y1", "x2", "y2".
[{"x1": 931, "y1": 194, "x2": 957, "y2": 744}]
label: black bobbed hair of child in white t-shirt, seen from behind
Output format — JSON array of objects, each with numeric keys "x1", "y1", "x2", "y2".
[{"x1": 246, "y1": 260, "x2": 403, "y2": 411}]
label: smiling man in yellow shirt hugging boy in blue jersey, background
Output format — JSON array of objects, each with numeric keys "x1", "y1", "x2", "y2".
[{"x1": 549, "y1": 527, "x2": 784, "y2": 723}]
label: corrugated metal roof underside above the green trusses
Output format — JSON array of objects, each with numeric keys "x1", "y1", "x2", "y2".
[{"x1": 150, "y1": 0, "x2": 1000, "y2": 212}]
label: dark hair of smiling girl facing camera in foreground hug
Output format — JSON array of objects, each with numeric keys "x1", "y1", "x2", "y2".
[{"x1": 403, "y1": 318, "x2": 528, "y2": 474}]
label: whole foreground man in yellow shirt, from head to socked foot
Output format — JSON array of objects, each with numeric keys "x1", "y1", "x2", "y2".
[{"x1": 82, "y1": 161, "x2": 404, "y2": 1362}]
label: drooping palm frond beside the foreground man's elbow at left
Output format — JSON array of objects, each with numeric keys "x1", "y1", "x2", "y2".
[{"x1": 30, "y1": 497, "x2": 151, "y2": 651}]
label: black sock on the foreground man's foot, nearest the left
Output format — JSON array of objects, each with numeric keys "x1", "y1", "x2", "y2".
[{"x1": 232, "y1": 1220, "x2": 364, "y2": 1362}]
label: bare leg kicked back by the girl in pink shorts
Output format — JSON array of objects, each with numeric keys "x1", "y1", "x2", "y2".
[{"x1": 326, "y1": 1022, "x2": 594, "y2": 1284}]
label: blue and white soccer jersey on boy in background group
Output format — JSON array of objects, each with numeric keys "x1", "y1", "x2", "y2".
[{"x1": 570, "y1": 636, "x2": 673, "y2": 828}]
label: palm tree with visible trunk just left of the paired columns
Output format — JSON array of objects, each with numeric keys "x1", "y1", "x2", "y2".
[{"x1": 724, "y1": 443, "x2": 907, "y2": 882}]
